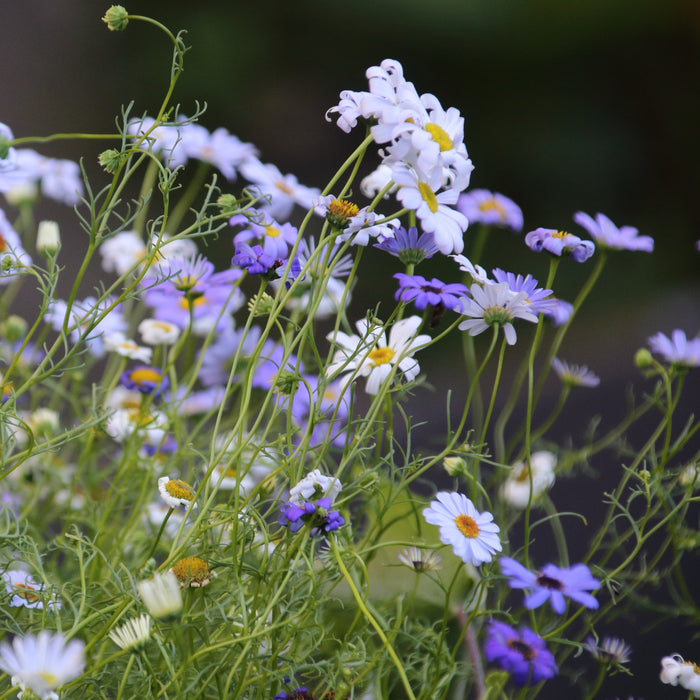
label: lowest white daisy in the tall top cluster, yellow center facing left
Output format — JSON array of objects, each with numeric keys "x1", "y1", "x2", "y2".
[{"x1": 392, "y1": 163, "x2": 469, "y2": 255}]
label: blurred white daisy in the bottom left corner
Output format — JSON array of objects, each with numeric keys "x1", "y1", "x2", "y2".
[{"x1": 0, "y1": 630, "x2": 85, "y2": 700}]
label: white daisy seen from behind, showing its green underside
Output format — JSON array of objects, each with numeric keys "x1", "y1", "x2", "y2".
[{"x1": 459, "y1": 281, "x2": 537, "y2": 345}]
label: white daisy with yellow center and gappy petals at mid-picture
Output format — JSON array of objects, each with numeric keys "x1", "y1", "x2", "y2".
[{"x1": 328, "y1": 316, "x2": 430, "y2": 394}]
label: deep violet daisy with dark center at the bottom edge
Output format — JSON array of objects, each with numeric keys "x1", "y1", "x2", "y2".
[{"x1": 484, "y1": 620, "x2": 558, "y2": 685}]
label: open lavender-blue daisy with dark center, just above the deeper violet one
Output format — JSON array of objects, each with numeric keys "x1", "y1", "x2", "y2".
[{"x1": 501, "y1": 557, "x2": 600, "y2": 615}]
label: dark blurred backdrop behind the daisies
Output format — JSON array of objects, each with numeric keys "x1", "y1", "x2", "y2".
[{"x1": 0, "y1": 0, "x2": 700, "y2": 700}]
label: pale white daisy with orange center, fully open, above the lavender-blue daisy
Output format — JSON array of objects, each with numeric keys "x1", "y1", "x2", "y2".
[{"x1": 423, "y1": 491, "x2": 502, "y2": 566}]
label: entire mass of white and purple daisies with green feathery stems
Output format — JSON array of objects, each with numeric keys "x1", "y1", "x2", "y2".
[{"x1": 0, "y1": 6, "x2": 700, "y2": 700}]
